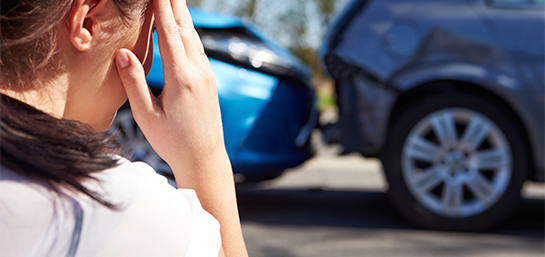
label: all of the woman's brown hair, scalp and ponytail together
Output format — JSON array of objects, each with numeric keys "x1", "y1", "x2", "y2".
[{"x1": 0, "y1": 0, "x2": 148, "y2": 207}]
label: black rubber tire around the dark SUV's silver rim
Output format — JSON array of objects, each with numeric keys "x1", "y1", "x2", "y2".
[{"x1": 381, "y1": 92, "x2": 529, "y2": 231}]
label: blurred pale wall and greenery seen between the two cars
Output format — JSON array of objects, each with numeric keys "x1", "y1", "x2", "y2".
[{"x1": 187, "y1": 0, "x2": 349, "y2": 110}]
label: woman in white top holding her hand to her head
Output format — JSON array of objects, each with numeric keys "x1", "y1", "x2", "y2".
[{"x1": 0, "y1": 0, "x2": 247, "y2": 256}]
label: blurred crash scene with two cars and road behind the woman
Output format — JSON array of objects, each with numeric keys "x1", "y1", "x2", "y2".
[{"x1": 113, "y1": 0, "x2": 545, "y2": 257}]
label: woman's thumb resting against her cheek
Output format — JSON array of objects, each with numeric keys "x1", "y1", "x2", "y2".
[{"x1": 115, "y1": 49, "x2": 160, "y2": 122}]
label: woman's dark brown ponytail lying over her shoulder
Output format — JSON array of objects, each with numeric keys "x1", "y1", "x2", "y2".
[{"x1": 0, "y1": 94, "x2": 119, "y2": 207}]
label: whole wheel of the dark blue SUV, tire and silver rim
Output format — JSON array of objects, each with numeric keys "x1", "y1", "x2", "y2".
[{"x1": 382, "y1": 93, "x2": 529, "y2": 230}]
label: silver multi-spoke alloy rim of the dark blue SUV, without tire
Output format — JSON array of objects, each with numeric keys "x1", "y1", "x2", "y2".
[{"x1": 401, "y1": 108, "x2": 513, "y2": 218}]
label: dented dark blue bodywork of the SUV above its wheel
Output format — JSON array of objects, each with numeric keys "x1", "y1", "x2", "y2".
[{"x1": 321, "y1": 0, "x2": 545, "y2": 180}]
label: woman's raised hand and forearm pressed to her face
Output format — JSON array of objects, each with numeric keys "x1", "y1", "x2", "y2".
[{"x1": 116, "y1": 0, "x2": 248, "y2": 256}]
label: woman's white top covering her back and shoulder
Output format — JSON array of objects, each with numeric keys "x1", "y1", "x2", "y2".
[{"x1": 0, "y1": 159, "x2": 221, "y2": 257}]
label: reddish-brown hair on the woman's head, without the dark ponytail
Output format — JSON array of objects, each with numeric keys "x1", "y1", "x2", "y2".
[{"x1": 0, "y1": 0, "x2": 143, "y2": 90}]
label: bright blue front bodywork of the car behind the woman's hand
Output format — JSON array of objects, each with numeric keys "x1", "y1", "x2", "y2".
[{"x1": 210, "y1": 59, "x2": 313, "y2": 176}]
